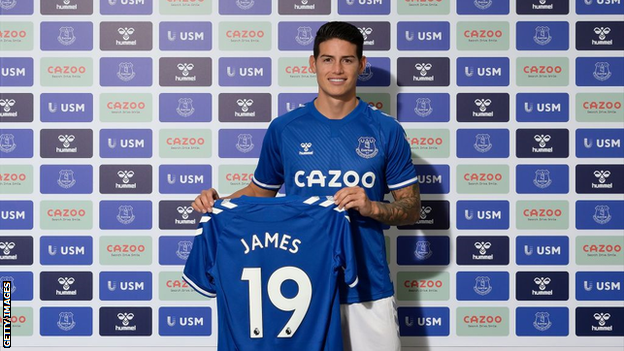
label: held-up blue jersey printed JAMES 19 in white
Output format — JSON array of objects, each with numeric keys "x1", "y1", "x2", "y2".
[{"x1": 183, "y1": 196, "x2": 358, "y2": 351}]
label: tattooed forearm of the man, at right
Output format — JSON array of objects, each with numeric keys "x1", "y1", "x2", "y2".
[{"x1": 371, "y1": 183, "x2": 420, "y2": 225}]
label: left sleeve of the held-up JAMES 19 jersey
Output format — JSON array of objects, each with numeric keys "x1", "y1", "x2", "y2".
[{"x1": 182, "y1": 214, "x2": 217, "y2": 297}]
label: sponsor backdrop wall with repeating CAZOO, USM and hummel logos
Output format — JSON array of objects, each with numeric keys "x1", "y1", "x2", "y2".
[{"x1": 0, "y1": 0, "x2": 624, "y2": 349}]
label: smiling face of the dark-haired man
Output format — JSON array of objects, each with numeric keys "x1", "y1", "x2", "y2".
[{"x1": 310, "y1": 39, "x2": 366, "y2": 101}]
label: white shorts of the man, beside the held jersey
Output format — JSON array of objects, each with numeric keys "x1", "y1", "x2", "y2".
[{"x1": 340, "y1": 296, "x2": 401, "y2": 351}]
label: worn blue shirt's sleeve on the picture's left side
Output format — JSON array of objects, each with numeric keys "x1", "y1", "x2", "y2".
[{"x1": 252, "y1": 123, "x2": 284, "y2": 191}]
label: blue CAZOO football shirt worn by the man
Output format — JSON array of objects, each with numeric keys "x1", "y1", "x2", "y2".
[{"x1": 253, "y1": 100, "x2": 418, "y2": 303}]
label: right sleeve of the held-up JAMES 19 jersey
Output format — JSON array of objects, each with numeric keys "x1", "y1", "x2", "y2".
[{"x1": 333, "y1": 212, "x2": 358, "y2": 288}]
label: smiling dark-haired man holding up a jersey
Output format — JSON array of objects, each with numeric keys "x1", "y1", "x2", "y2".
[{"x1": 193, "y1": 22, "x2": 420, "y2": 351}]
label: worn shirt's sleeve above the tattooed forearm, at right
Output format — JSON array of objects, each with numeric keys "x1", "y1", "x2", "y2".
[{"x1": 386, "y1": 122, "x2": 418, "y2": 190}]
